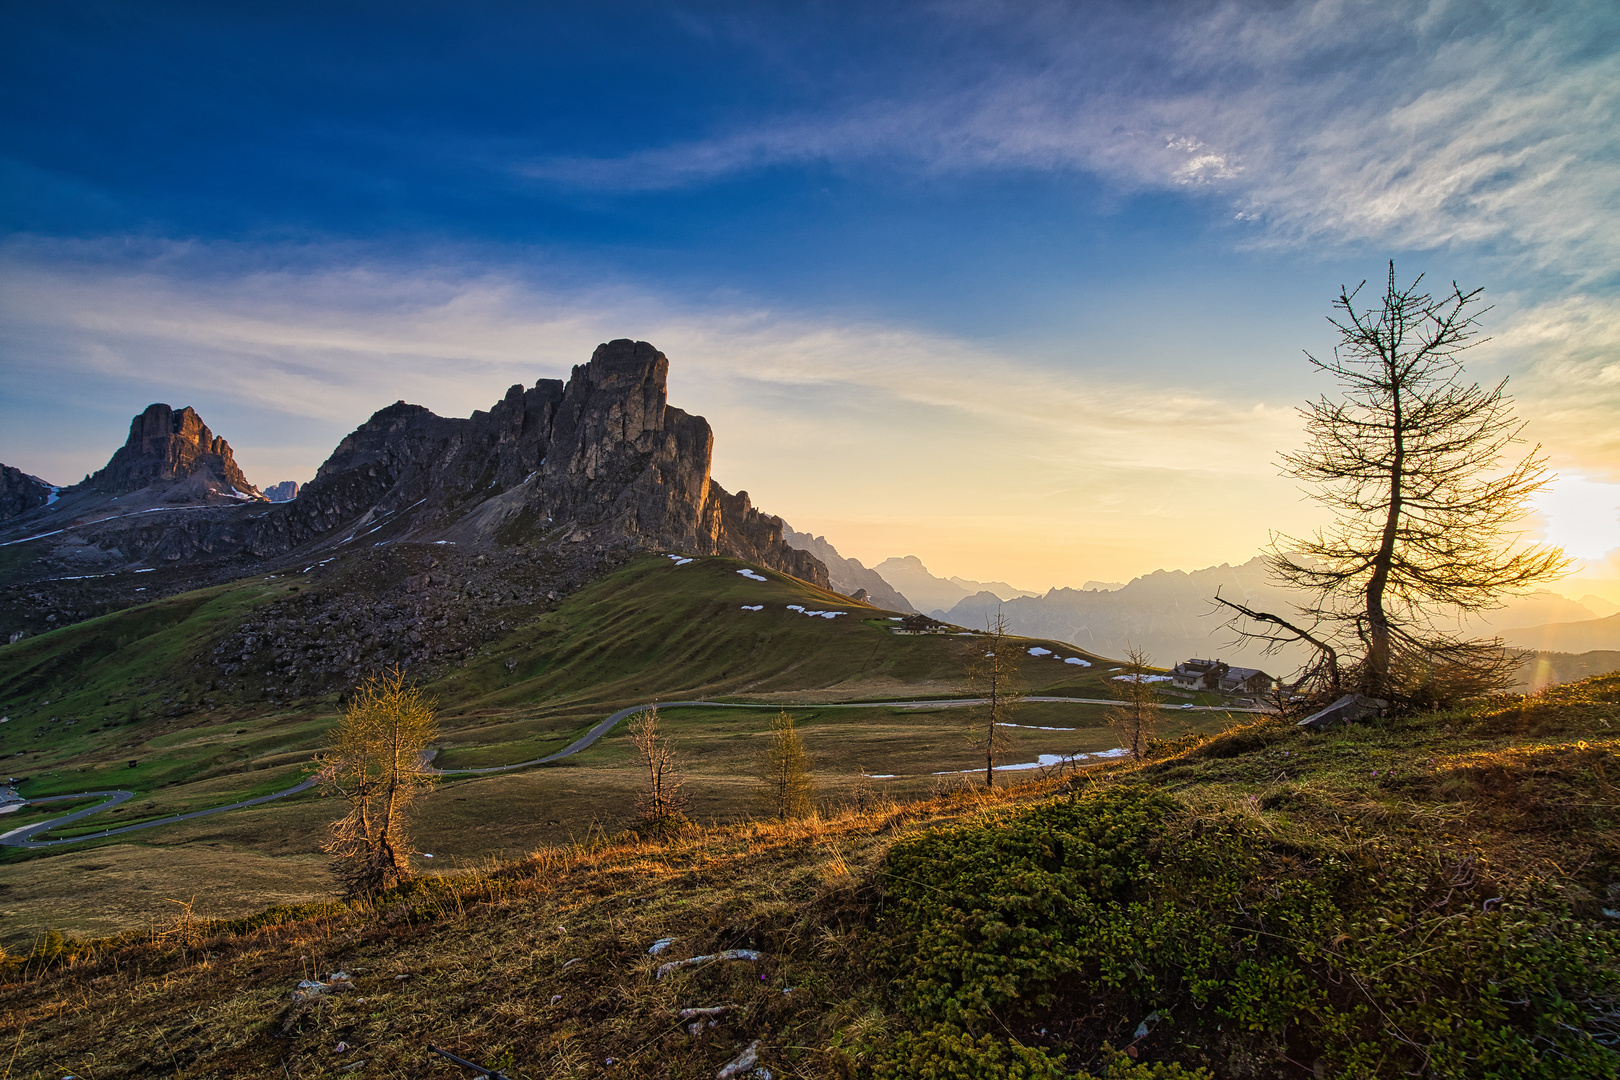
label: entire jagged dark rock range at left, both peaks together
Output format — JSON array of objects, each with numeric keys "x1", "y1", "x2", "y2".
[{"x1": 0, "y1": 340, "x2": 829, "y2": 637}]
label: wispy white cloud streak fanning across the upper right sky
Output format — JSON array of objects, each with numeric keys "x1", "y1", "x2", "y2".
[{"x1": 520, "y1": 0, "x2": 1620, "y2": 279}]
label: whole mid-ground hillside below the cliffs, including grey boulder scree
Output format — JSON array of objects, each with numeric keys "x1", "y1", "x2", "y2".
[{"x1": 0, "y1": 544, "x2": 1230, "y2": 947}]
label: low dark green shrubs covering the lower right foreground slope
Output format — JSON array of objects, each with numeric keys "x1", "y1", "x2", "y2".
[{"x1": 870, "y1": 785, "x2": 1620, "y2": 1080}]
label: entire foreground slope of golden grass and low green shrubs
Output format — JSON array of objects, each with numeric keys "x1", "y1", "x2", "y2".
[{"x1": 0, "y1": 677, "x2": 1620, "y2": 1080}]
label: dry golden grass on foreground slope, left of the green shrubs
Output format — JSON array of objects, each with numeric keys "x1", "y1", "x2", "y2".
[{"x1": 0, "y1": 780, "x2": 1075, "y2": 1080}]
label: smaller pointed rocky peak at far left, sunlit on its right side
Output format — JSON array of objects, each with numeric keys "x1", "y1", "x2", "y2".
[{"x1": 79, "y1": 405, "x2": 259, "y2": 502}]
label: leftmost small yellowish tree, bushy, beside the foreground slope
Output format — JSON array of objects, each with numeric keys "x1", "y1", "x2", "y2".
[{"x1": 316, "y1": 667, "x2": 439, "y2": 895}]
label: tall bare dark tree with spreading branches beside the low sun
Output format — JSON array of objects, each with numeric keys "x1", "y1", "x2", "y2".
[{"x1": 1217, "y1": 262, "x2": 1568, "y2": 703}]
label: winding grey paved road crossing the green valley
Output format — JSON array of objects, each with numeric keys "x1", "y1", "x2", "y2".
[{"x1": 0, "y1": 695, "x2": 1265, "y2": 848}]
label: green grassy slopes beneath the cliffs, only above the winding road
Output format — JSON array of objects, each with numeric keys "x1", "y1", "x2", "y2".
[{"x1": 0, "y1": 557, "x2": 1127, "y2": 795}]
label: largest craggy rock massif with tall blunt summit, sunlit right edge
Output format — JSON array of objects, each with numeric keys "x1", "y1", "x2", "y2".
[{"x1": 265, "y1": 340, "x2": 828, "y2": 586}]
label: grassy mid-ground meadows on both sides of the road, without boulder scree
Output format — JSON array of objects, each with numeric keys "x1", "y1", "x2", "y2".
[{"x1": 0, "y1": 557, "x2": 1230, "y2": 947}]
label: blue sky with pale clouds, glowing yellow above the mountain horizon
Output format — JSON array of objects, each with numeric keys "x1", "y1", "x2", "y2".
[{"x1": 9, "y1": 0, "x2": 1620, "y2": 601}]
